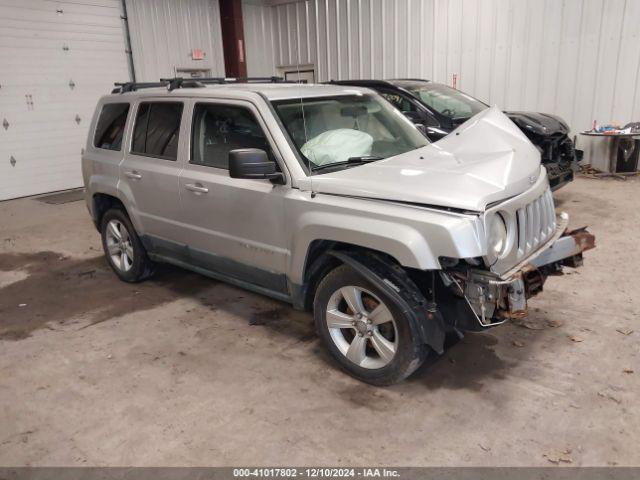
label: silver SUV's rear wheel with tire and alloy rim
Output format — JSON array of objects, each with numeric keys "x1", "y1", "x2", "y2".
[{"x1": 100, "y1": 208, "x2": 155, "y2": 283}]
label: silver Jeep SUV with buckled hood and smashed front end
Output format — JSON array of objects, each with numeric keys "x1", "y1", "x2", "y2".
[{"x1": 82, "y1": 79, "x2": 594, "y2": 385}]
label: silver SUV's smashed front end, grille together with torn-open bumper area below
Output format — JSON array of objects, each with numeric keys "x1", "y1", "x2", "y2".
[{"x1": 437, "y1": 169, "x2": 595, "y2": 330}]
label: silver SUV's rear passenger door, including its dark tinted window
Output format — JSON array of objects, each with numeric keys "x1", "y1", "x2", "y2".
[{"x1": 119, "y1": 99, "x2": 184, "y2": 248}]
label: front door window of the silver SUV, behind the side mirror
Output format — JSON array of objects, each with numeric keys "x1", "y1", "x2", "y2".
[{"x1": 191, "y1": 103, "x2": 273, "y2": 170}]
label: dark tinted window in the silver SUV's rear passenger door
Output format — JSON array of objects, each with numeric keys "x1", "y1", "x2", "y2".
[{"x1": 131, "y1": 102, "x2": 183, "y2": 160}]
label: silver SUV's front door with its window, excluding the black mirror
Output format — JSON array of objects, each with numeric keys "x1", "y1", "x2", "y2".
[{"x1": 180, "y1": 101, "x2": 289, "y2": 293}]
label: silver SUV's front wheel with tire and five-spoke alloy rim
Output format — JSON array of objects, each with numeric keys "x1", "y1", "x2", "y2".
[{"x1": 314, "y1": 265, "x2": 428, "y2": 385}]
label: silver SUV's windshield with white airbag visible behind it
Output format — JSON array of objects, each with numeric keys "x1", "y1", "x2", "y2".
[{"x1": 272, "y1": 95, "x2": 429, "y2": 171}]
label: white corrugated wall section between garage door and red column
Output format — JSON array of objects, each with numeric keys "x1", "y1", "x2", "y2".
[{"x1": 126, "y1": 0, "x2": 224, "y2": 81}]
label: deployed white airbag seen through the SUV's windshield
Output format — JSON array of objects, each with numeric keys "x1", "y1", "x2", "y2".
[{"x1": 300, "y1": 128, "x2": 373, "y2": 165}]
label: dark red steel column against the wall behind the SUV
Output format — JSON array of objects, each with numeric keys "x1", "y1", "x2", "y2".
[{"x1": 220, "y1": 0, "x2": 247, "y2": 78}]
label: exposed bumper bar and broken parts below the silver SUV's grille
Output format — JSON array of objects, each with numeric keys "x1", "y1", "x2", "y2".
[{"x1": 443, "y1": 215, "x2": 595, "y2": 327}]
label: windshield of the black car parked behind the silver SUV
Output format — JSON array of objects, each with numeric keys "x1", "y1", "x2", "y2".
[{"x1": 409, "y1": 83, "x2": 487, "y2": 118}]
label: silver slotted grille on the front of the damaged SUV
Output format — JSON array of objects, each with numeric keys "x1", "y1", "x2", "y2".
[{"x1": 516, "y1": 188, "x2": 556, "y2": 260}]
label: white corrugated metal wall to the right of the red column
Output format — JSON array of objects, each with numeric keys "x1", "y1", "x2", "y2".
[{"x1": 244, "y1": 0, "x2": 640, "y2": 167}]
